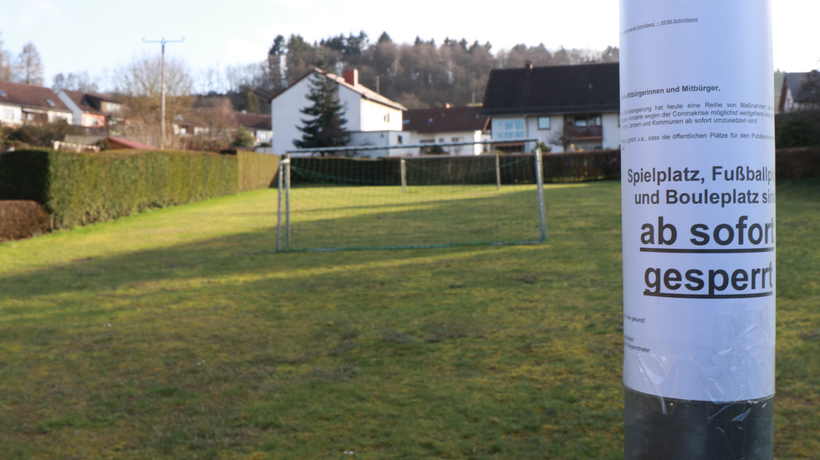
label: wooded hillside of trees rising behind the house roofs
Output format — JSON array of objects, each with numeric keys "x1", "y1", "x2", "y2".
[{"x1": 211, "y1": 31, "x2": 618, "y2": 108}]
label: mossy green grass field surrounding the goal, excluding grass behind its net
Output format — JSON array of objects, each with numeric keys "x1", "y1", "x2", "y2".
[{"x1": 0, "y1": 181, "x2": 820, "y2": 460}]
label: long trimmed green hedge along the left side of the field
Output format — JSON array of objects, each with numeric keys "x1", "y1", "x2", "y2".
[{"x1": 0, "y1": 149, "x2": 239, "y2": 228}]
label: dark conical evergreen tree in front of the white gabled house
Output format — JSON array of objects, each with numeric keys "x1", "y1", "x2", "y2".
[{"x1": 293, "y1": 72, "x2": 350, "y2": 149}]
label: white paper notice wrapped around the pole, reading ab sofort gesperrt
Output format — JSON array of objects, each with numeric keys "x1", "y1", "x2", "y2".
[{"x1": 620, "y1": 0, "x2": 776, "y2": 402}]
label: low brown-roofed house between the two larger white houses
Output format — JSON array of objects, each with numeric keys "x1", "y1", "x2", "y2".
[{"x1": 402, "y1": 104, "x2": 490, "y2": 155}]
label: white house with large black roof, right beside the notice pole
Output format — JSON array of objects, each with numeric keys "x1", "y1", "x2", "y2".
[{"x1": 481, "y1": 62, "x2": 621, "y2": 152}]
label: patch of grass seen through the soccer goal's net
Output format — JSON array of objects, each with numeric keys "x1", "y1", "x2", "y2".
[{"x1": 283, "y1": 184, "x2": 541, "y2": 250}]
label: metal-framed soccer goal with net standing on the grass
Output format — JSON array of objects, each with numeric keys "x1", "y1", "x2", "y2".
[{"x1": 277, "y1": 139, "x2": 547, "y2": 251}]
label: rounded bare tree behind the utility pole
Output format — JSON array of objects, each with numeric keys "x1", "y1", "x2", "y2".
[{"x1": 114, "y1": 54, "x2": 193, "y2": 148}]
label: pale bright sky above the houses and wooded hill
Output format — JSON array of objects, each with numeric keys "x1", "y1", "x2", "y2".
[{"x1": 0, "y1": 0, "x2": 820, "y2": 92}]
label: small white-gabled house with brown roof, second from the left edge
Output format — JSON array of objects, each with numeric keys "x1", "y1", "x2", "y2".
[{"x1": 57, "y1": 90, "x2": 125, "y2": 130}]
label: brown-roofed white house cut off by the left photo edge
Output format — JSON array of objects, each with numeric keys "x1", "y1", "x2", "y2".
[{"x1": 0, "y1": 81, "x2": 72, "y2": 126}]
